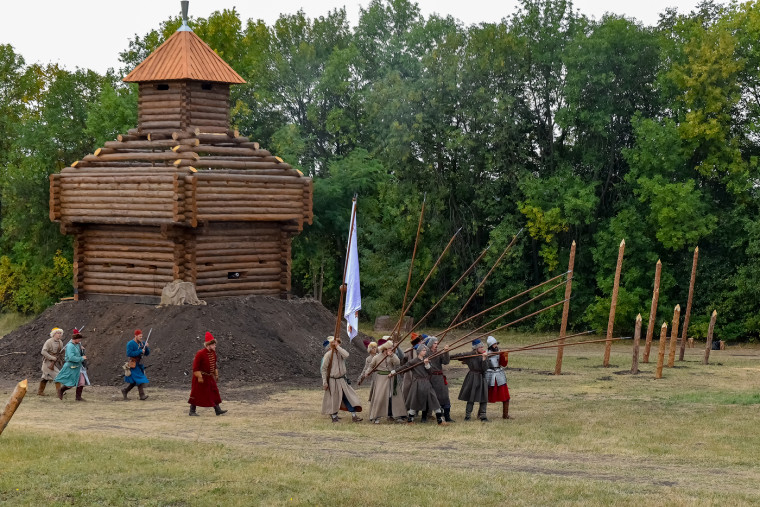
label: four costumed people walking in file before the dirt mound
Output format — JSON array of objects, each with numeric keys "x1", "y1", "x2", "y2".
[{"x1": 37, "y1": 327, "x2": 227, "y2": 416}]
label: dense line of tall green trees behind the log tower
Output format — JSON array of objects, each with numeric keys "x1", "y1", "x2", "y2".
[{"x1": 0, "y1": 0, "x2": 760, "y2": 340}]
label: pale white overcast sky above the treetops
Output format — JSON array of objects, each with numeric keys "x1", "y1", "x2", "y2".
[{"x1": 0, "y1": 0, "x2": 699, "y2": 73}]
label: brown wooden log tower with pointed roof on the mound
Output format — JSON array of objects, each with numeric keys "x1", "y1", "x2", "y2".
[{"x1": 50, "y1": 12, "x2": 313, "y2": 303}]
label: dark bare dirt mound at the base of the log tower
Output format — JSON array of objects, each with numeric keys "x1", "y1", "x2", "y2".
[{"x1": 0, "y1": 296, "x2": 368, "y2": 385}]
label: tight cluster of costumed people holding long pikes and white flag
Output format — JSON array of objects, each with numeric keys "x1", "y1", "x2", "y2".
[{"x1": 320, "y1": 333, "x2": 511, "y2": 425}]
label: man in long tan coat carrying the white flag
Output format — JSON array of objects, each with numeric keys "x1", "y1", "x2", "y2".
[{"x1": 320, "y1": 336, "x2": 362, "y2": 422}]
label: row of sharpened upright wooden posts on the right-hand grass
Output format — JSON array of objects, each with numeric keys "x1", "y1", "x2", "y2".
[{"x1": 554, "y1": 240, "x2": 722, "y2": 379}]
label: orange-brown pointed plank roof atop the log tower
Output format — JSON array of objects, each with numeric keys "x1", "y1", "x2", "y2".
[{"x1": 124, "y1": 30, "x2": 245, "y2": 84}]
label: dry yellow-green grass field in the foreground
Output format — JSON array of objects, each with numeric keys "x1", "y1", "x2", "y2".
[{"x1": 0, "y1": 335, "x2": 760, "y2": 506}]
